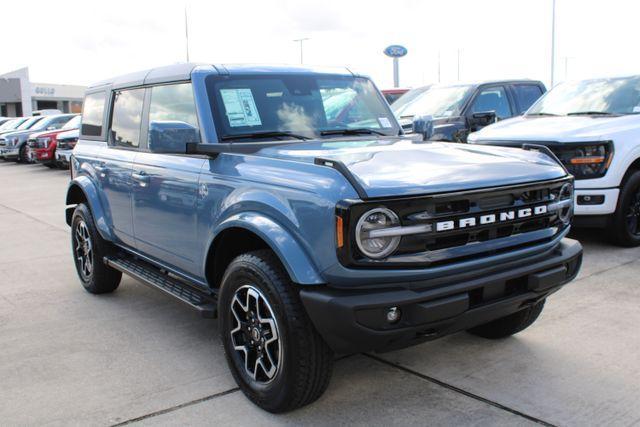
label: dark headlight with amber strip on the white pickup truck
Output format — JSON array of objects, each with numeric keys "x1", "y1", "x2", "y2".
[{"x1": 553, "y1": 141, "x2": 613, "y2": 179}]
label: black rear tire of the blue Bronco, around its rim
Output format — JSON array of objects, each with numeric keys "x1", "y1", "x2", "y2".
[{"x1": 71, "y1": 203, "x2": 122, "y2": 294}]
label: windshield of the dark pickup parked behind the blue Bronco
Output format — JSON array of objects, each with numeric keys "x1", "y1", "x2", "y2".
[{"x1": 393, "y1": 85, "x2": 473, "y2": 118}]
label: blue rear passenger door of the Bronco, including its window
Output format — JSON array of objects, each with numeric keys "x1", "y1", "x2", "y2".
[{"x1": 96, "y1": 89, "x2": 145, "y2": 247}]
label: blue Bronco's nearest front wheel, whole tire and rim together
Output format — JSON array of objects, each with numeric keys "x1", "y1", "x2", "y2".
[{"x1": 218, "y1": 250, "x2": 333, "y2": 413}]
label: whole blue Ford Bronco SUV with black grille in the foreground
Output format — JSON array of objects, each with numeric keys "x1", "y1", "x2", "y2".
[{"x1": 66, "y1": 64, "x2": 582, "y2": 412}]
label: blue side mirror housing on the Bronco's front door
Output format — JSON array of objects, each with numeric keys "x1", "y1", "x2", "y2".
[{"x1": 149, "y1": 121, "x2": 200, "y2": 154}]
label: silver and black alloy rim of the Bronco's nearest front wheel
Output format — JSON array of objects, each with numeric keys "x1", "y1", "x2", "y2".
[{"x1": 230, "y1": 285, "x2": 282, "y2": 384}]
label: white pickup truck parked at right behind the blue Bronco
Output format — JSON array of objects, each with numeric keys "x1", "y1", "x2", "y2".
[{"x1": 469, "y1": 76, "x2": 640, "y2": 246}]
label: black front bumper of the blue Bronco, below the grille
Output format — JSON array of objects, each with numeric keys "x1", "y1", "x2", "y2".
[{"x1": 300, "y1": 238, "x2": 582, "y2": 353}]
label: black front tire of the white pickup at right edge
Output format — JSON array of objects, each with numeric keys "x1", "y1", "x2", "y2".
[{"x1": 608, "y1": 171, "x2": 640, "y2": 247}]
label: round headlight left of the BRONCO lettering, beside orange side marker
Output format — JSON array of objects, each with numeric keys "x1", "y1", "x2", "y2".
[{"x1": 356, "y1": 208, "x2": 400, "y2": 259}]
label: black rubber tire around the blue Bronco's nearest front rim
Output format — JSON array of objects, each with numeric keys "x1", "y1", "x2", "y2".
[{"x1": 218, "y1": 250, "x2": 333, "y2": 413}]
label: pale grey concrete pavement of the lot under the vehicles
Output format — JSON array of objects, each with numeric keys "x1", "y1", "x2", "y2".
[{"x1": 0, "y1": 161, "x2": 640, "y2": 426}]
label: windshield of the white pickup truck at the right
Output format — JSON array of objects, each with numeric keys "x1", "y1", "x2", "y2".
[{"x1": 527, "y1": 76, "x2": 640, "y2": 116}]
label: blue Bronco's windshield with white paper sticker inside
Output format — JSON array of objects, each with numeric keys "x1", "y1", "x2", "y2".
[{"x1": 206, "y1": 74, "x2": 399, "y2": 139}]
